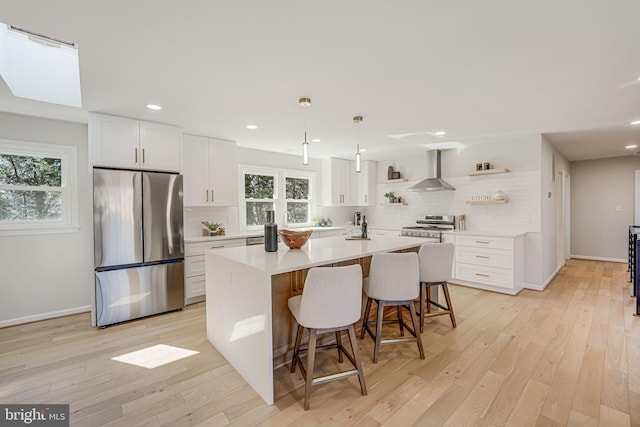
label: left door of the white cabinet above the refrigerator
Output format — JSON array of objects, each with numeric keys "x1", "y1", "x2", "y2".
[{"x1": 89, "y1": 113, "x2": 141, "y2": 169}]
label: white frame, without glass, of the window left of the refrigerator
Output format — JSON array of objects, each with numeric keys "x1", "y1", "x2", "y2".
[{"x1": 0, "y1": 138, "x2": 79, "y2": 236}]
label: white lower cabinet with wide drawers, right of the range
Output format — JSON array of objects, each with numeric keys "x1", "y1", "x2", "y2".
[{"x1": 452, "y1": 235, "x2": 524, "y2": 295}]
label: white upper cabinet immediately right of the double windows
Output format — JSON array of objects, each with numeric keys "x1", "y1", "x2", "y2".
[{"x1": 322, "y1": 158, "x2": 357, "y2": 206}]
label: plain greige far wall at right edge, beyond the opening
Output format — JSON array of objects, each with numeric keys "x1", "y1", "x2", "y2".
[{"x1": 571, "y1": 156, "x2": 640, "y2": 262}]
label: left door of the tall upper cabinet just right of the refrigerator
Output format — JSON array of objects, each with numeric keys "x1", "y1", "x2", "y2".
[{"x1": 181, "y1": 135, "x2": 211, "y2": 206}]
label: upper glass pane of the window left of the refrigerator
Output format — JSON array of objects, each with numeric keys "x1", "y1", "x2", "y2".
[{"x1": 0, "y1": 154, "x2": 62, "y2": 187}]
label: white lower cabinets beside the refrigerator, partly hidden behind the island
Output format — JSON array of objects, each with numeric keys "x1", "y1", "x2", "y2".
[{"x1": 184, "y1": 238, "x2": 246, "y2": 304}]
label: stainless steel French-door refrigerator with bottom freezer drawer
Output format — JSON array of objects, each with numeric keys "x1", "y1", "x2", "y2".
[{"x1": 93, "y1": 168, "x2": 184, "y2": 327}]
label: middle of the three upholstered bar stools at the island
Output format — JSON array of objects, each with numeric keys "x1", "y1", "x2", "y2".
[{"x1": 360, "y1": 252, "x2": 424, "y2": 363}]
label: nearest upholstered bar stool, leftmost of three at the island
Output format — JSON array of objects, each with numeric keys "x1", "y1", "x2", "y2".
[{"x1": 288, "y1": 264, "x2": 367, "y2": 410}]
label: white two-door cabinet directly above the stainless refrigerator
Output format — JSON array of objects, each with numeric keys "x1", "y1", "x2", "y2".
[{"x1": 89, "y1": 113, "x2": 182, "y2": 172}]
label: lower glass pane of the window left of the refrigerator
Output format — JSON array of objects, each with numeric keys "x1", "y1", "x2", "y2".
[{"x1": 0, "y1": 190, "x2": 62, "y2": 221}]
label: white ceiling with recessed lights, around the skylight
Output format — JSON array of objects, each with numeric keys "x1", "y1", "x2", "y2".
[{"x1": 0, "y1": 0, "x2": 640, "y2": 160}]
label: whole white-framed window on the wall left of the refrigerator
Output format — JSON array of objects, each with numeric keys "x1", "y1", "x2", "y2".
[{"x1": 0, "y1": 140, "x2": 77, "y2": 234}]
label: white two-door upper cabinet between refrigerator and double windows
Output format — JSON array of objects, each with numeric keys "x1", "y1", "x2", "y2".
[{"x1": 182, "y1": 134, "x2": 238, "y2": 206}]
